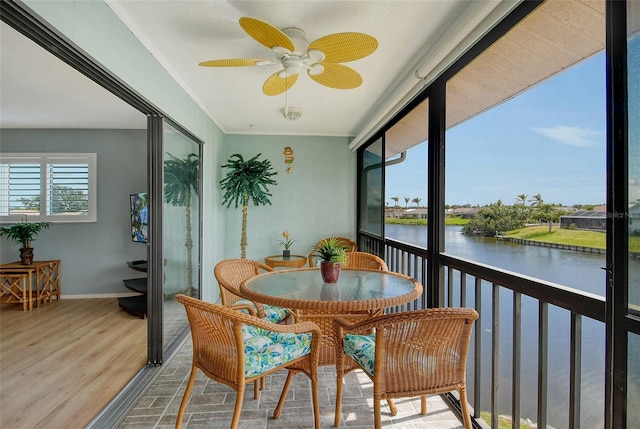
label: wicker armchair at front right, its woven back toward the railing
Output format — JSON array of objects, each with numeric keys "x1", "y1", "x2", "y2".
[{"x1": 334, "y1": 308, "x2": 478, "y2": 429}]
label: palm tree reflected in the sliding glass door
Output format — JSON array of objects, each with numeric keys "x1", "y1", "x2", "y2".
[{"x1": 164, "y1": 153, "x2": 200, "y2": 294}]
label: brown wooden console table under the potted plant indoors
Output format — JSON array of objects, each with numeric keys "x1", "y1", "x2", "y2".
[{"x1": 0, "y1": 260, "x2": 61, "y2": 310}]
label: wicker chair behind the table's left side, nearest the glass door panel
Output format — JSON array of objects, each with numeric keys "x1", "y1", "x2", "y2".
[{"x1": 213, "y1": 259, "x2": 290, "y2": 323}]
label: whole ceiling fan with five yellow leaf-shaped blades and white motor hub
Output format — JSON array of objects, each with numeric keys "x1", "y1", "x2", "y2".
[{"x1": 199, "y1": 17, "x2": 378, "y2": 95}]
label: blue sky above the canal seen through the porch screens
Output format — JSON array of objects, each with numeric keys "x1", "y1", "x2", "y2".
[{"x1": 386, "y1": 54, "x2": 606, "y2": 206}]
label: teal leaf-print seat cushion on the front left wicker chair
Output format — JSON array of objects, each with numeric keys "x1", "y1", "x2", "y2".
[{"x1": 242, "y1": 325, "x2": 311, "y2": 377}]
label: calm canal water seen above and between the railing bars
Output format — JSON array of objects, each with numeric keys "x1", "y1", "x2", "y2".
[{"x1": 385, "y1": 224, "x2": 628, "y2": 429}]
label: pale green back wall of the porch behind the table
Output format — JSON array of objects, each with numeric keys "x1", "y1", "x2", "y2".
[{"x1": 218, "y1": 135, "x2": 356, "y2": 260}]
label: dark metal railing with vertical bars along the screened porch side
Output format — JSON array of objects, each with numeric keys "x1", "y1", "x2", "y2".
[{"x1": 358, "y1": 234, "x2": 605, "y2": 429}]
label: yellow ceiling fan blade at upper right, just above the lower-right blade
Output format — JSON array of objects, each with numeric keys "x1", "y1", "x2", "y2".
[{"x1": 307, "y1": 33, "x2": 378, "y2": 63}]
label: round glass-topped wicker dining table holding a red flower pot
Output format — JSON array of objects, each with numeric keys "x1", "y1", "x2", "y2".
[{"x1": 240, "y1": 268, "x2": 422, "y2": 365}]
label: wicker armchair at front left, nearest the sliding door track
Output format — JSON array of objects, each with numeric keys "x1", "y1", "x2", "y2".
[{"x1": 175, "y1": 294, "x2": 322, "y2": 429}]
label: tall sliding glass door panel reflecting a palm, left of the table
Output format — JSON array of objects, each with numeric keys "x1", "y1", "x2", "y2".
[{"x1": 148, "y1": 115, "x2": 202, "y2": 365}]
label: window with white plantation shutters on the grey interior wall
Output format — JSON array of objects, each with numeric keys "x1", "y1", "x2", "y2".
[{"x1": 0, "y1": 153, "x2": 97, "y2": 222}]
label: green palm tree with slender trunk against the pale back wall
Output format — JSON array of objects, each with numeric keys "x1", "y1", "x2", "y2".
[{"x1": 220, "y1": 153, "x2": 278, "y2": 259}]
